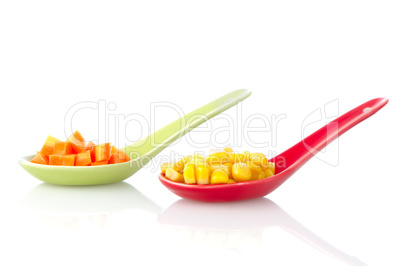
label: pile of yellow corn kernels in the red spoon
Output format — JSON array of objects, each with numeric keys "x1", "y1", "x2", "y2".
[{"x1": 161, "y1": 148, "x2": 275, "y2": 185}]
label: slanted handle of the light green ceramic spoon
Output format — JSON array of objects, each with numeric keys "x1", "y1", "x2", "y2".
[{"x1": 124, "y1": 89, "x2": 251, "y2": 160}]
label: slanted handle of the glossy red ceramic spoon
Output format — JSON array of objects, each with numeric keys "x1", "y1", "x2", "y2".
[{"x1": 271, "y1": 98, "x2": 388, "y2": 173}]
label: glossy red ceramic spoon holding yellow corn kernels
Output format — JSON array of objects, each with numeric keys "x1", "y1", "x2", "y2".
[{"x1": 159, "y1": 98, "x2": 388, "y2": 202}]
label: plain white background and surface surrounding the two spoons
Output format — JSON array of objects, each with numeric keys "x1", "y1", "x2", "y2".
[{"x1": 0, "y1": 0, "x2": 402, "y2": 265}]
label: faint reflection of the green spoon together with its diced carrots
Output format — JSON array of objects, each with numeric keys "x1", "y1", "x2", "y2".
[{"x1": 19, "y1": 182, "x2": 162, "y2": 233}]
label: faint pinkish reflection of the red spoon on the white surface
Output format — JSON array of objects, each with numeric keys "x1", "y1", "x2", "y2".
[{"x1": 158, "y1": 198, "x2": 366, "y2": 265}]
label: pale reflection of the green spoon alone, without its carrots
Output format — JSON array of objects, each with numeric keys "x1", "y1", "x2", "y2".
[{"x1": 20, "y1": 182, "x2": 162, "y2": 216}]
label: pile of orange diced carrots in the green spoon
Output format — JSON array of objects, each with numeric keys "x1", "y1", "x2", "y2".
[{"x1": 31, "y1": 131, "x2": 130, "y2": 166}]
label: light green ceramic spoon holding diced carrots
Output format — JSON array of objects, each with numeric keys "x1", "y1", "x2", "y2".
[{"x1": 19, "y1": 89, "x2": 251, "y2": 185}]
